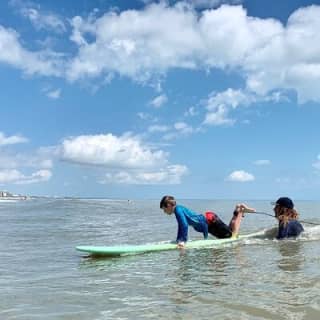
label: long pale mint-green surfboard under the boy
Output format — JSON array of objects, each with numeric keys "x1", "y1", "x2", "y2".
[{"x1": 76, "y1": 233, "x2": 259, "y2": 257}]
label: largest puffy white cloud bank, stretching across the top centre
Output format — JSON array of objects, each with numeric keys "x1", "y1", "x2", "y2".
[{"x1": 69, "y1": 2, "x2": 268, "y2": 79}]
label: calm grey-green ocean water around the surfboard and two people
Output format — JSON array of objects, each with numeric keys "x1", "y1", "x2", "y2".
[{"x1": 0, "y1": 198, "x2": 320, "y2": 320}]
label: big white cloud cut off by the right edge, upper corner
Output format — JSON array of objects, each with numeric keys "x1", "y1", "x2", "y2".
[{"x1": 246, "y1": 5, "x2": 320, "y2": 103}]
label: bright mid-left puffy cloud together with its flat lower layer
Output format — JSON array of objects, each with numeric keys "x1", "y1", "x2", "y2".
[{"x1": 60, "y1": 133, "x2": 188, "y2": 184}]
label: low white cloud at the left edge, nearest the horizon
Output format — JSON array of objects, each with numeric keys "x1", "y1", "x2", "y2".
[{"x1": 0, "y1": 169, "x2": 52, "y2": 185}]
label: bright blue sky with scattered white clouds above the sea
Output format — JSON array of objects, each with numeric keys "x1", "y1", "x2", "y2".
[{"x1": 0, "y1": 0, "x2": 320, "y2": 200}]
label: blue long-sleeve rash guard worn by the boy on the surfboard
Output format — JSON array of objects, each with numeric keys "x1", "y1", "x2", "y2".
[{"x1": 174, "y1": 205, "x2": 208, "y2": 242}]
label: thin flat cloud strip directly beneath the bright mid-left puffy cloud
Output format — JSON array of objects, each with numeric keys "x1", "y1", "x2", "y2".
[{"x1": 100, "y1": 165, "x2": 188, "y2": 185}]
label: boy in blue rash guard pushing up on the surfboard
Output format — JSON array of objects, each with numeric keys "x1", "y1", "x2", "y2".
[{"x1": 160, "y1": 196, "x2": 256, "y2": 248}]
